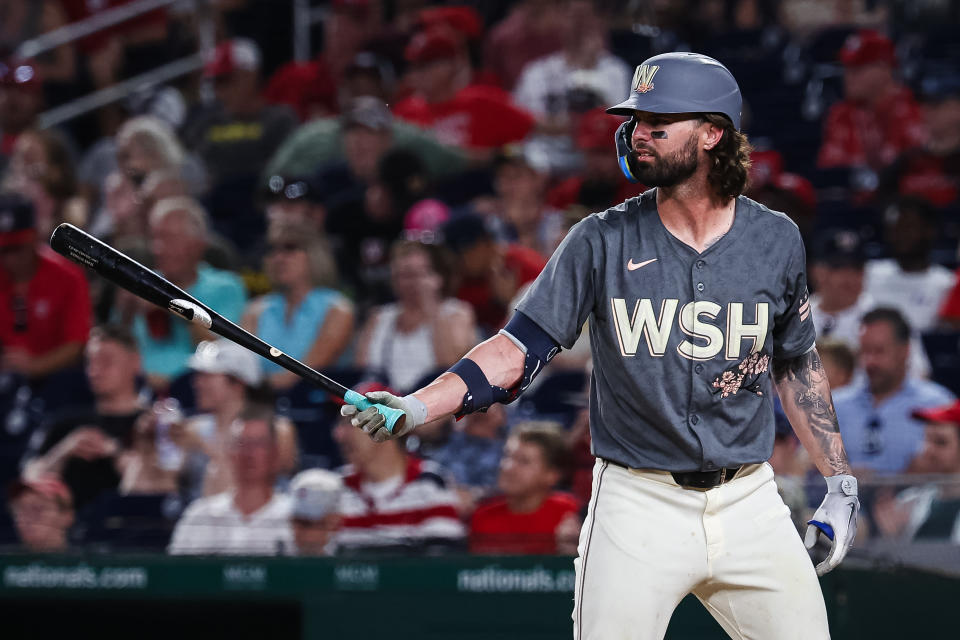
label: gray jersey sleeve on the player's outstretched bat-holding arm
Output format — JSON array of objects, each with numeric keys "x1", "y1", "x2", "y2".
[{"x1": 517, "y1": 216, "x2": 603, "y2": 349}]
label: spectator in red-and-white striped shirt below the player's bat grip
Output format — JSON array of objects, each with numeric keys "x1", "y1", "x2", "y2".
[{"x1": 333, "y1": 385, "x2": 465, "y2": 553}]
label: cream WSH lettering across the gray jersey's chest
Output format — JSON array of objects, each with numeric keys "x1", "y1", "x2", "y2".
[{"x1": 610, "y1": 298, "x2": 770, "y2": 360}]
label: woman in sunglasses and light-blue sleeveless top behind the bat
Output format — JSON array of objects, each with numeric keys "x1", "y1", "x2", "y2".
[{"x1": 242, "y1": 221, "x2": 354, "y2": 390}]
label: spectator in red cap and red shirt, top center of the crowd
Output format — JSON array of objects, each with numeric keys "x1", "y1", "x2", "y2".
[{"x1": 393, "y1": 27, "x2": 535, "y2": 150}]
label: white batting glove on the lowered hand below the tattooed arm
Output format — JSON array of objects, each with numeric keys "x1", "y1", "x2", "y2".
[{"x1": 803, "y1": 475, "x2": 860, "y2": 576}]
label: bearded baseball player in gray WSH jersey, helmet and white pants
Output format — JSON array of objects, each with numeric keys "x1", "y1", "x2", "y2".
[{"x1": 344, "y1": 53, "x2": 859, "y2": 640}]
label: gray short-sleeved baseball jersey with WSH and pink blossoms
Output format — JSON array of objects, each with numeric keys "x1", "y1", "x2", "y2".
[{"x1": 517, "y1": 189, "x2": 816, "y2": 471}]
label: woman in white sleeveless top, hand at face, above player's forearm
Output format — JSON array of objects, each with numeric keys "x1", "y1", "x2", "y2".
[{"x1": 357, "y1": 240, "x2": 477, "y2": 391}]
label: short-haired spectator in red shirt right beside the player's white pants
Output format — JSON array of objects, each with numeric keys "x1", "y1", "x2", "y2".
[{"x1": 470, "y1": 423, "x2": 580, "y2": 554}]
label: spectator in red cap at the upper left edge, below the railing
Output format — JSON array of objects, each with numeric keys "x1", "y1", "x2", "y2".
[{"x1": 0, "y1": 58, "x2": 43, "y2": 169}]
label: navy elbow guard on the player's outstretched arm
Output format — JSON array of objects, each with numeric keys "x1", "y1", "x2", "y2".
[{"x1": 449, "y1": 311, "x2": 560, "y2": 420}]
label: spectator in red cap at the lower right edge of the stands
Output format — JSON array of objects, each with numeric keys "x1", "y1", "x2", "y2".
[{"x1": 873, "y1": 401, "x2": 960, "y2": 544}]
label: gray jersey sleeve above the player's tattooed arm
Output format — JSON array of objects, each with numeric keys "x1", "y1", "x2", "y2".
[{"x1": 773, "y1": 227, "x2": 817, "y2": 359}]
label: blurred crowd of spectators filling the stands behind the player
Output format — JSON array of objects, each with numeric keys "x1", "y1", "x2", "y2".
[{"x1": 0, "y1": 0, "x2": 960, "y2": 554}]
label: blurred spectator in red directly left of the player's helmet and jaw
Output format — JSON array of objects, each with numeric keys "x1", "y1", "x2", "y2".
[{"x1": 547, "y1": 107, "x2": 644, "y2": 211}]
